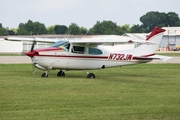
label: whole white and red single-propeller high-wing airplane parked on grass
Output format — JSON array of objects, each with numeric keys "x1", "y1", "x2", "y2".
[{"x1": 5, "y1": 27, "x2": 170, "y2": 78}]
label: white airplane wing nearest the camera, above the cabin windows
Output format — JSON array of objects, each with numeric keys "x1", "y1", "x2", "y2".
[{"x1": 69, "y1": 37, "x2": 155, "y2": 45}]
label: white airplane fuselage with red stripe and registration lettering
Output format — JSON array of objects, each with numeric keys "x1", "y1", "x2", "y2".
[{"x1": 32, "y1": 45, "x2": 151, "y2": 70}]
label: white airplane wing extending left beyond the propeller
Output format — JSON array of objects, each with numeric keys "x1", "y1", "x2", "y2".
[{"x1": 4, "y1": 37, "x2": 59, "y2": 43}]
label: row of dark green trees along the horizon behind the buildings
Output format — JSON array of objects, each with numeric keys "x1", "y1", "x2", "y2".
[{"x1": 0, "y1": 11, "x2": 180, "y2": 36}]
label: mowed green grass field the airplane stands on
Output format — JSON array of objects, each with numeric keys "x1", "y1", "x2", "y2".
[{"x1": 0, "y1": 64, "x2": 180, "y2": 120}]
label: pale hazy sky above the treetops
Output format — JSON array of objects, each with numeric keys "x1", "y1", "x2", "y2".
[{"x1": 0, "y1": 0, "x2": 180, "y2": 29}]
